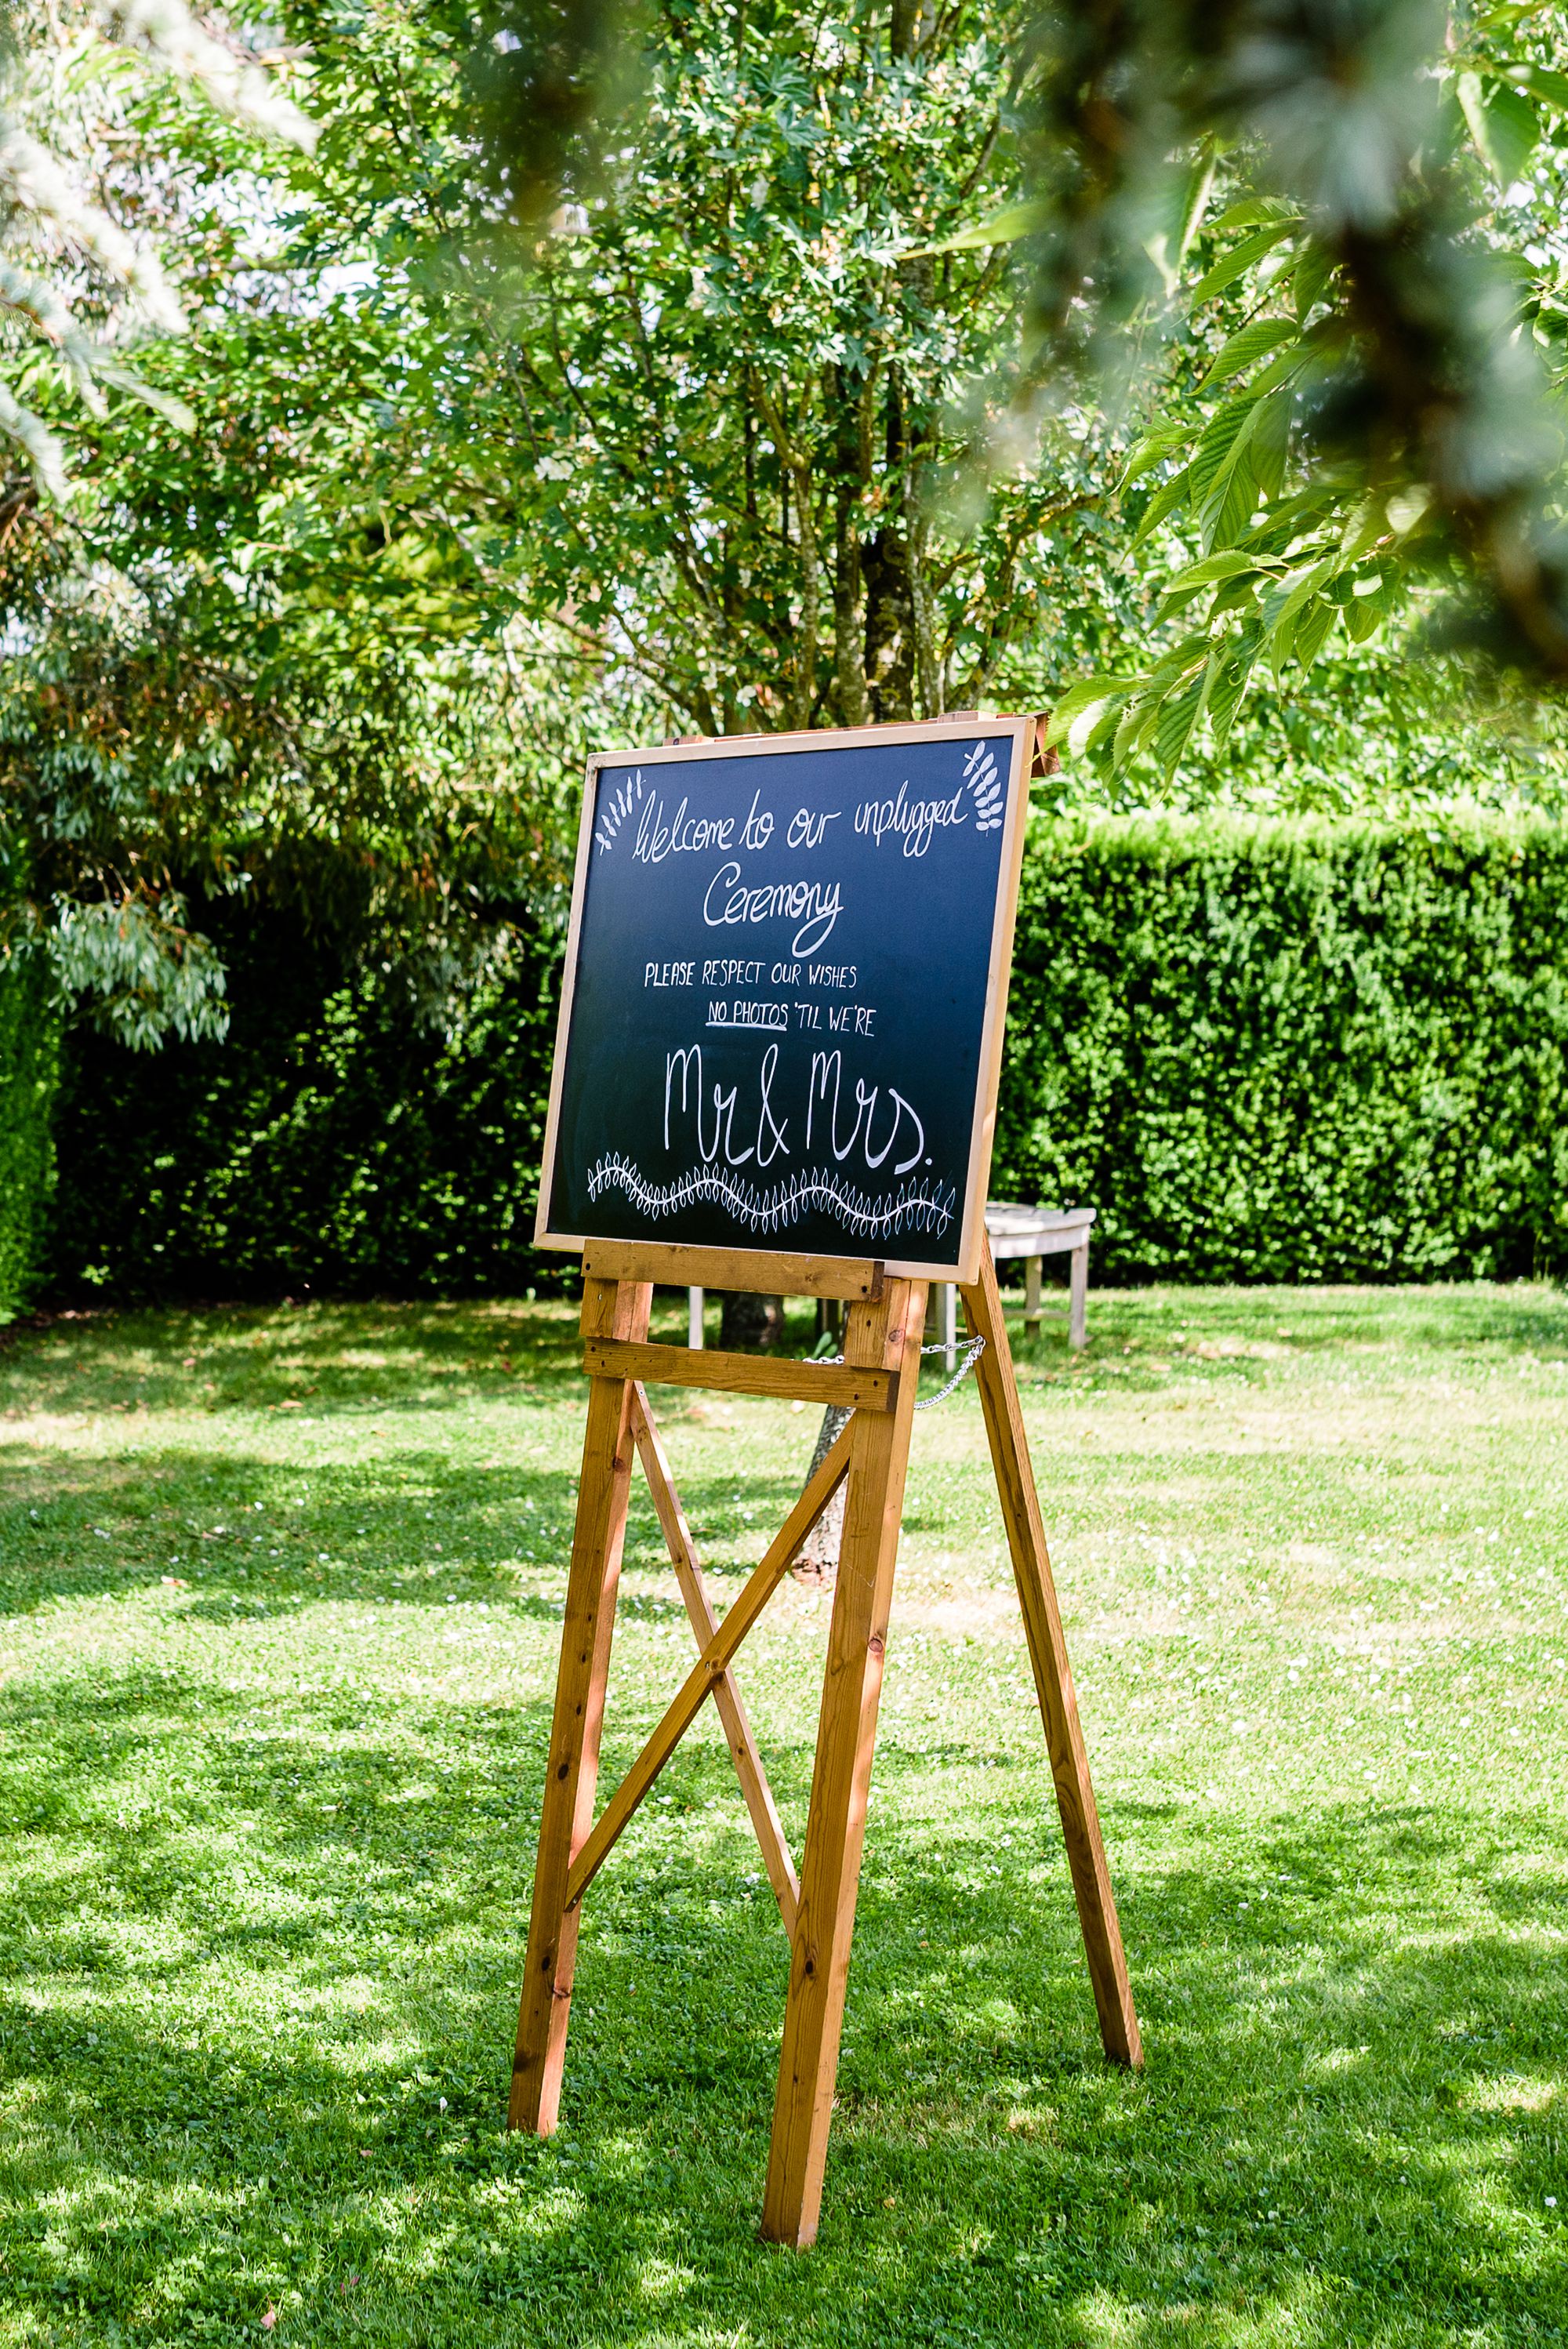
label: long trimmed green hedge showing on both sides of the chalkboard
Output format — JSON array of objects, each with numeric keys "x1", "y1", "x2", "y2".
[{"x1": 39, "y1": 818, "x2": 1568, "y2": 1297}]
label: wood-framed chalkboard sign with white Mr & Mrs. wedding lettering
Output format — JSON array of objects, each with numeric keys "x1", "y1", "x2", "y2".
[{"x1": 538, "y1": 719, "x2": 1033, "y2": 1280}]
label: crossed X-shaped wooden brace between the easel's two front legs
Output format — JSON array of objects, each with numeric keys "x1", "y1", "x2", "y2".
[{"x1": 566, "y1": 1384, "x2": 855, "y2": 1938}]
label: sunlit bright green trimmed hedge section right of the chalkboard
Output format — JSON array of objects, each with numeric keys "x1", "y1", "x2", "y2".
[{"x1": 990, "y1": 818, "x2": 1568, "y2": 1280}]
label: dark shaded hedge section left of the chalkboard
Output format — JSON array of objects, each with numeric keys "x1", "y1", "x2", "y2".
[{"x1": 49, "y1": 902, "x2": 561, "y2": 1299}]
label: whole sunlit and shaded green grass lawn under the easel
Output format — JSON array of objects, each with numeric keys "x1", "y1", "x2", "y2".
[{"x1": 0, "y1": 1287, "x2": 1568, "y2": 2349}]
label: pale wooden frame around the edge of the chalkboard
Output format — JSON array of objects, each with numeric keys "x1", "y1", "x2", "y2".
[{"x1": 533, "y1": 714, "x2": 1037, "y2": 1285}]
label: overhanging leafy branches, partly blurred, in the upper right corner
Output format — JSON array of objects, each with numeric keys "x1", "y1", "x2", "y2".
[{"x1": 975, "y1": 0, "x2": 1568, "y2": 775}]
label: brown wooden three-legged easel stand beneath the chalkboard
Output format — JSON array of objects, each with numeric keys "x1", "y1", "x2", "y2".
[{"x1": 507, "y1": 1240, "x2": 1143, "y2": 2248}]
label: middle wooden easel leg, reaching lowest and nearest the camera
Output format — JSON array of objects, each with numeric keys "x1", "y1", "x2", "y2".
[{"x1": 763, "y1": 1280, "x2": 925, "y2": 2250}]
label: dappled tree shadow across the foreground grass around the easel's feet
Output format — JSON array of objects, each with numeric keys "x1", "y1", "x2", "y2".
[{"x1": 0, "y1": 1672, "x2": 1568, "y2": 2349}]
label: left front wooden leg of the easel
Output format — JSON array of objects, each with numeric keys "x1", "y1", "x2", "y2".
[{"x1": 507, "y1": 1280, "x2": 652, "y2": 2137}]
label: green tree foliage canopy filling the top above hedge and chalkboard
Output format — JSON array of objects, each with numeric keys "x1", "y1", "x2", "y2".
[{"x1": 0, "y1": 0, "x2": 1568, "y2": 1043}]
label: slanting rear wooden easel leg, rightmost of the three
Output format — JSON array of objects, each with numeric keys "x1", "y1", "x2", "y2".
[{"x1": 963, "y1": 1247, "x2": 1143, "y2": 2067}]
